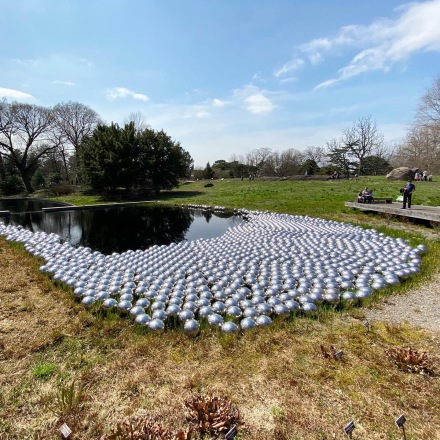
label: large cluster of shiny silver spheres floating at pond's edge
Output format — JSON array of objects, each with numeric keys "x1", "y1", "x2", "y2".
[{"x1": 0, "y1": 210, "x2": 426, "y2": 332}]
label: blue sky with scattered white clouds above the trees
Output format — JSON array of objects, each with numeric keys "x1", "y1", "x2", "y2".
[{"x1": 0, "y1": 0, "x2": 440, "y2": 167}]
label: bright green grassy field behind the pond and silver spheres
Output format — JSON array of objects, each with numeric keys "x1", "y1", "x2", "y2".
[{"x1": 52, "y1": 176, "x2": 440, "y2": 218}]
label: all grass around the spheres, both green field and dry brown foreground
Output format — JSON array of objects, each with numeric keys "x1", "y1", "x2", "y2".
[{"x1": 0, "y1": 177, "x2": 440, "y2": 440}]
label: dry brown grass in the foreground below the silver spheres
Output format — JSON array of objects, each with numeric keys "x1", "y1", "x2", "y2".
[{"x1": 0, "y1": 239, "x2": 440, "y2": 440}]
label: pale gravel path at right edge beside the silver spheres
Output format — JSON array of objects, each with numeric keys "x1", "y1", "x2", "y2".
[{"x1": 364, "y1": 272, "x2": 440, "y2": 333}]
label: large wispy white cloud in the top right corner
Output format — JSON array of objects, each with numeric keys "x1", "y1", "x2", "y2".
[{"x1": 312, "y1": 0, "x2": 440, "y2": 89}]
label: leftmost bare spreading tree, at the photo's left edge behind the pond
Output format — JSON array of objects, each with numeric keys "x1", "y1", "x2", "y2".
[{"x1": 0, "y1": 100, "x2": 58, "y2": 193}]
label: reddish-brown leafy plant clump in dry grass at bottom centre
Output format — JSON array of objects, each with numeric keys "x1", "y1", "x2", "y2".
[{"x1": 185, "y1": 393, "x2": 240, "y2": 435}]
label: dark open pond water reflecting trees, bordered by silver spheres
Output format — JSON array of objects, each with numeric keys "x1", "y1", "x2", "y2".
[{"x1": 1, "y1": 206, "x2": 243, "y2": 254}]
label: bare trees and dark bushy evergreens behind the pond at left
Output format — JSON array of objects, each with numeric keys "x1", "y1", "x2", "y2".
[{"x1": 0, "y1": 99, "x2": 193, "y2": 194}]
